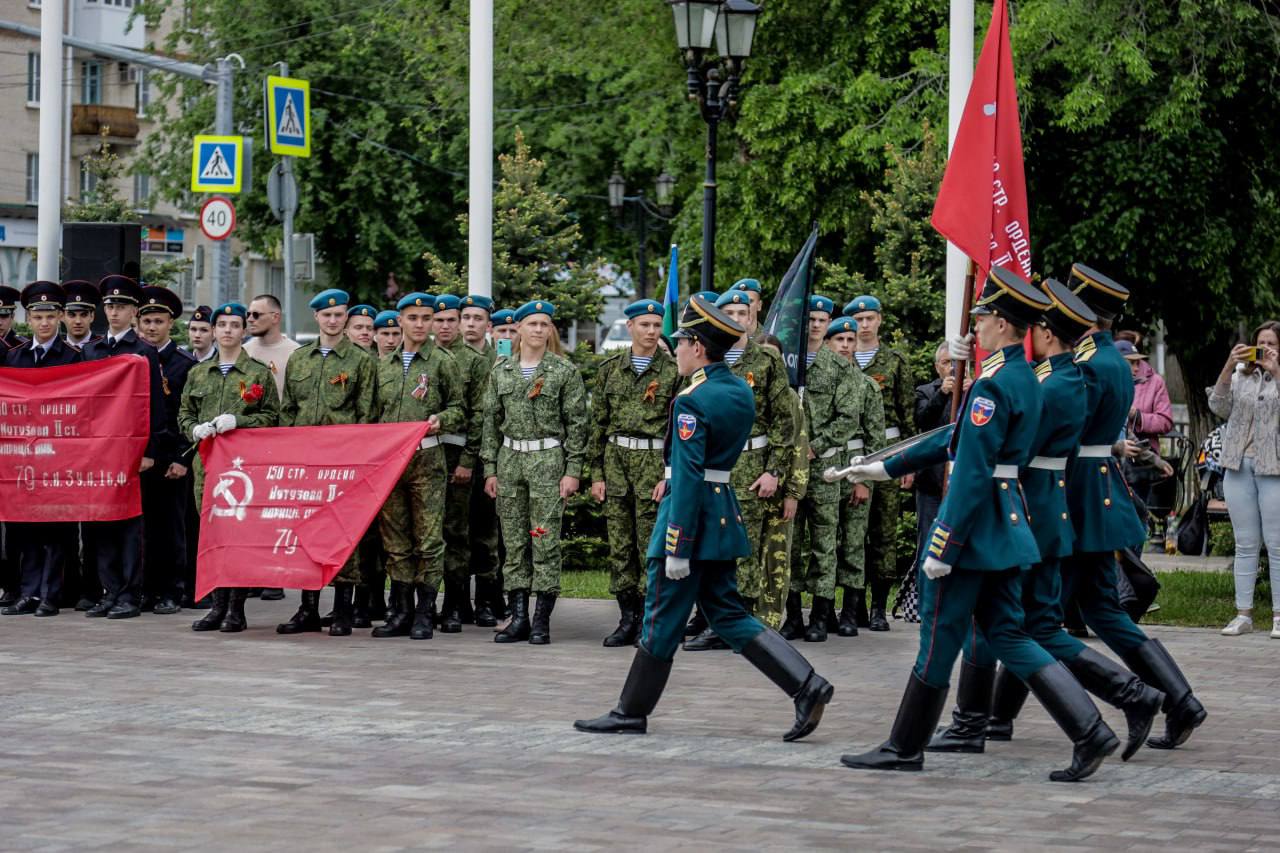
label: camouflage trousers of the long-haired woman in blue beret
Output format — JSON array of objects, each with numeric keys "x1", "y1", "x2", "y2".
[{"x1": 495, "y1": 447, "x2": 564, "y2": 596}]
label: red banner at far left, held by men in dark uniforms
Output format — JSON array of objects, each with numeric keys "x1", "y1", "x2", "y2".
[{"x1": 0, "y1": 355, "x2": 151, "y2": 521}]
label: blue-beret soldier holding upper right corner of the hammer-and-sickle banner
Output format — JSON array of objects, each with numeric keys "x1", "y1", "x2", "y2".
[{"x1": 372, "y1": 293, "x2": 465, "y2": 639}]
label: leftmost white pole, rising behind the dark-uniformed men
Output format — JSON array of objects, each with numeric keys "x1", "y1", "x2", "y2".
[{"x1": 36, "y1": 0, "x2": 63, "y2": 282}]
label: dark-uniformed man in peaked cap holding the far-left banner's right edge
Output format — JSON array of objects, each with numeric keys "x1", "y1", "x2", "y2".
[{"x1": 82, "y1": 275, "x2": 169, "y2": 619}]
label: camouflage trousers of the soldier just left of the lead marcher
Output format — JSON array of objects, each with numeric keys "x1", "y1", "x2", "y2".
[{"x1": 604, "y1": 443, "x2": 663, "y2": 597}]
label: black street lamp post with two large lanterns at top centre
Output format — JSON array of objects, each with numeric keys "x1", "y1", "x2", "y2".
[{"x1": 667, "y1": 0, "x2": 760, "y2": 291}]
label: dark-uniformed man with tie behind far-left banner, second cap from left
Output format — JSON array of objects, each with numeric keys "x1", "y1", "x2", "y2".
[{"x1": 0, "y1": 282, "x2": 81, "y2": 616}]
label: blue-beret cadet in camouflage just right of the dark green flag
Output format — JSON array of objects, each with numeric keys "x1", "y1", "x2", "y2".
[{"x1": 782, "y1": 296, "x2": 859, "y2": 643}]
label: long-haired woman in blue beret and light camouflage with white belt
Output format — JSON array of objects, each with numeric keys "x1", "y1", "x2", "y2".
[{"x1": 480, "y1": 300, "x2": 588, "y2": 646}]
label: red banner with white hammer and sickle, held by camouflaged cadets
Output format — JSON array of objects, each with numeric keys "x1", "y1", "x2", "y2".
[{"x1": 196, "y1": 421, "x2": 426, "y2": 598}]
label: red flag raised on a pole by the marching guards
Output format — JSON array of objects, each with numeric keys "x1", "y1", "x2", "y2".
[{"x1": 932, "y1": 0, "x2": 1032, "y2": 281}]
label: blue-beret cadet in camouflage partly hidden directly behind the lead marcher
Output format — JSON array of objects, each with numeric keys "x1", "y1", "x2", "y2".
[{"x1": 685, "y1": 289, "x2": 796, "y2": 652}]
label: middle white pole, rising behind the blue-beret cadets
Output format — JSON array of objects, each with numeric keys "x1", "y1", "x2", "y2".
[{"x1": 467, "y1": 0, "x2": 493, "y2": 296}]
